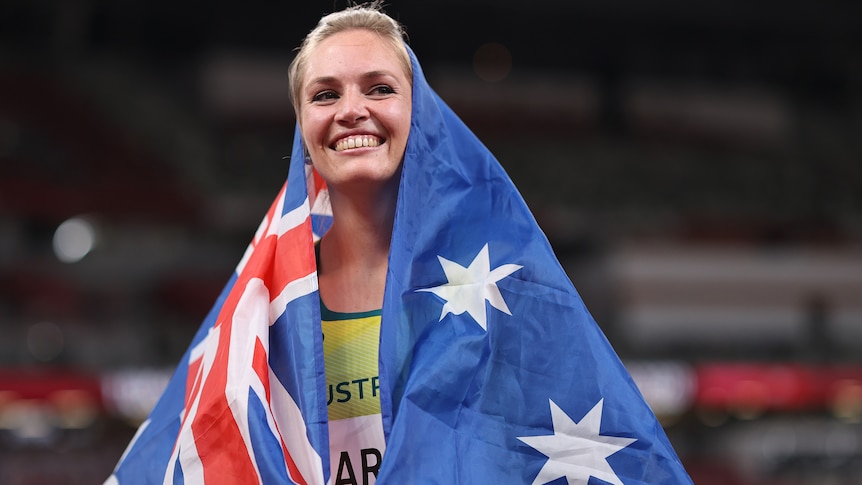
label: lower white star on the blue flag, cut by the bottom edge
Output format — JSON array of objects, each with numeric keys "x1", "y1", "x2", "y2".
[{"x1": 518, "y1": 399, "x2": 637, "y2": 485}]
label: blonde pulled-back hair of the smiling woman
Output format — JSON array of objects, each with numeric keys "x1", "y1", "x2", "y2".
[{"x1": 288, "y1": 1, "x2": 413, "y2": 111}]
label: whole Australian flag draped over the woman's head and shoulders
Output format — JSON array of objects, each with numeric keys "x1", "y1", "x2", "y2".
[{"x1": 109, "y1": 42, "x2": 691, "y2": 485}]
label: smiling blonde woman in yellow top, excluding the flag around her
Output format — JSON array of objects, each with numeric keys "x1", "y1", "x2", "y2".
[{"x1": 290, "y1": 4, "x2": 413, "y2": 483}]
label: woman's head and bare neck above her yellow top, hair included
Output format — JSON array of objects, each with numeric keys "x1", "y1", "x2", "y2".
[{"x1": 290, "y1": 8, "x2": 412, "y2": 312}]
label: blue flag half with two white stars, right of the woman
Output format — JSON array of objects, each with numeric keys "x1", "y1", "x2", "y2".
[{"x1": 379, "y1": 48, "x2": 691, "y2": 485}]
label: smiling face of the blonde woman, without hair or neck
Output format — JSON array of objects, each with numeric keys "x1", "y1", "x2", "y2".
[{"x1": 299, "y1": 30, "x2": 412, "y2": 190}]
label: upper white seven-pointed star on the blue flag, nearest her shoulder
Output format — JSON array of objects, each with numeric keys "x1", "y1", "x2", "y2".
[{"x1": 417, "y1": 244, "x2": 521, "y2": 330}]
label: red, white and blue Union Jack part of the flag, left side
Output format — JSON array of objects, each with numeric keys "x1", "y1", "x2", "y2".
[{"x1": 106, "y1": 150, "x2": 331, "y2": 484}]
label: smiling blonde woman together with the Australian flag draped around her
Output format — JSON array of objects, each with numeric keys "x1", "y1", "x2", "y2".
[{"x1": 109, "y1": 5, "x2": 691, "y2": 485}]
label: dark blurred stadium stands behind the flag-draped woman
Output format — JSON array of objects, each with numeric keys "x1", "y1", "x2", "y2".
[{"x1": 0, "y1": 0, "x2": 862, "y2": 485}]
